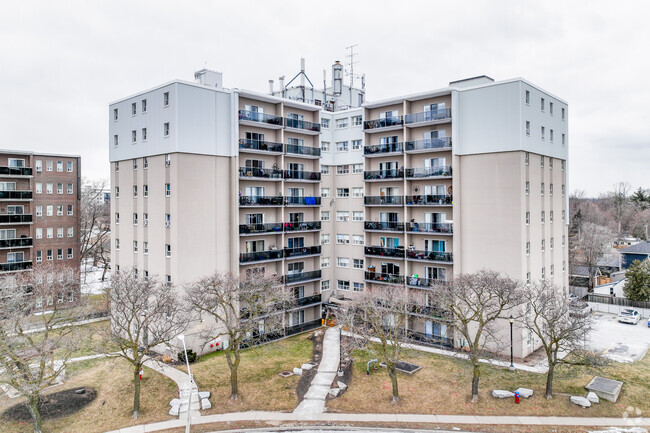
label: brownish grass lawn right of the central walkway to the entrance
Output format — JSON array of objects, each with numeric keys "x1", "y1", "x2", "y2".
[{"x1": 327, "y1": 344, "x2": 650, "y2": 417}]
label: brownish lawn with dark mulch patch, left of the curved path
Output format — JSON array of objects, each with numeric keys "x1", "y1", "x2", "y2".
[{"x1": 0, "y1": 359, "x2": 178, "y2": 433}]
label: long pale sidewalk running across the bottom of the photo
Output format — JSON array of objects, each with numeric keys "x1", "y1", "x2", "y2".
[{"x1": 107, "y1": 411, "x2": 650, "y2": 433}]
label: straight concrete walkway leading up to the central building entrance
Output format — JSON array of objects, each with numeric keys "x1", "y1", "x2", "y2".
[{"x1": 293, "y1": 327, "x2": 341, "y2": 416}]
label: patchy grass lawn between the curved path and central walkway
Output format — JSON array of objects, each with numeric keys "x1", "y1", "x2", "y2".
[{"x1": 179, "y1": 334, "x2": 313, "y2": 414}]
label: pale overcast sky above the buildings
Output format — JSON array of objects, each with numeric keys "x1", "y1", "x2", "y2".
[{"x1": 0, "y1": 0, "x2": 650, "y2": 195}]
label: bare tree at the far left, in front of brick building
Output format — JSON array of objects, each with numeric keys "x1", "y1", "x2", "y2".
[{"x1": 0, "y1": 265, "x2": 83, "y2": 433}]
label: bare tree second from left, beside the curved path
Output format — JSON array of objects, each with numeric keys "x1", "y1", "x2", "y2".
[{"x1": 98, "y1": 270, "x2": 187, "y2": 418}]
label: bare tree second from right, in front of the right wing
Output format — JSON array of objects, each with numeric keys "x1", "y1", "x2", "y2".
[{"x1": 433, "y1": 270, "x2": 521, "y2": 402}]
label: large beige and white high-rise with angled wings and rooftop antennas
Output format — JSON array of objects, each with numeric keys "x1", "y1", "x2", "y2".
[{"x1": 109, "y1": 68, "x2": 568, "y2": 356}]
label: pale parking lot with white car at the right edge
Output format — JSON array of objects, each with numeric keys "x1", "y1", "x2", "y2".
[{"x1": 586, "y1": 312, "x2": 650, "y2": 362}]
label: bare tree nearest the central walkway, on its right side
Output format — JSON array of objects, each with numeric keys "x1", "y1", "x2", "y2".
[{"x1": 338, "y1": 284, "x2": 424, "y2": 403}]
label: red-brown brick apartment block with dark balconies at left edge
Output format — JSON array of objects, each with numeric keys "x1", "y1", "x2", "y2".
[{"x1": 0, "y1": 150, "x2": 81, "y2": 309}]
